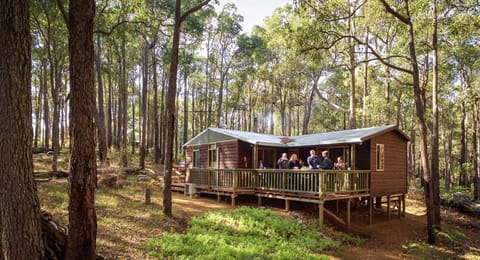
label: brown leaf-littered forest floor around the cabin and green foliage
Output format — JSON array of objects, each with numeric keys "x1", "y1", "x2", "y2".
[{"x1": 34, "y1": 157, "x2": 480, "y2": 259}]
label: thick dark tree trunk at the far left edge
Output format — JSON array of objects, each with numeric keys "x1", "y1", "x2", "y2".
[{"x1": 0, "y1": 0, "x2": 44, "y2": 259}]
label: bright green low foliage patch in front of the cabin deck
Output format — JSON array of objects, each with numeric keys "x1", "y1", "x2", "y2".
[{"x1": 147, "y1": 207, "x2": 358, "y2": 259}]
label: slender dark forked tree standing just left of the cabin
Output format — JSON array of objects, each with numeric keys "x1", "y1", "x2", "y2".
[{"x1": 163, "y1": 0, "x2": 210, "y2": 217}]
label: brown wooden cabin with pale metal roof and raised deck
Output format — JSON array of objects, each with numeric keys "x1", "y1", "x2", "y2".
[{"x1": 180, "y1": 125, "x2": 409, "y2": 226}]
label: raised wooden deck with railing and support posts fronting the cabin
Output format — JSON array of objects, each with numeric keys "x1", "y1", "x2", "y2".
[{"x1": 172, "y1": 169, "x2": 386, "y2": 227}]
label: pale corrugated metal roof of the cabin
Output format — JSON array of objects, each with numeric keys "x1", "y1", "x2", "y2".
[{"x1": 184, "y1": 125, "x2": 409, "y2": 147}]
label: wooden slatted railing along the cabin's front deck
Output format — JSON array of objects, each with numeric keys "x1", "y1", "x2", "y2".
[{"x1": 189, "y1": 168, "x2": 370, "y2": 195}]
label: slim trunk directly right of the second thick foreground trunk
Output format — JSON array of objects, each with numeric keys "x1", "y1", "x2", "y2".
[{"x1": 95, "y1": 36, "x2": 107, "y2": 165}]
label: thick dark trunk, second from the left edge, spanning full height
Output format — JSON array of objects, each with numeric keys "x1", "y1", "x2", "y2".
[{"x1": 66, "y1": 0, "x2": 97, "y2": 259}]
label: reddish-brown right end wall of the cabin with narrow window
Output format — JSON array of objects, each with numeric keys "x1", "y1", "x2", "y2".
[{"x1": 370, "y1": 131, "x2": 407, "y2": 196}]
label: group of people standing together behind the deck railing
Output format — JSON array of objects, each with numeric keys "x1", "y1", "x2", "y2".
[{"x1": 277, "y1": 149, "x2": 345, "y2": 170}]
